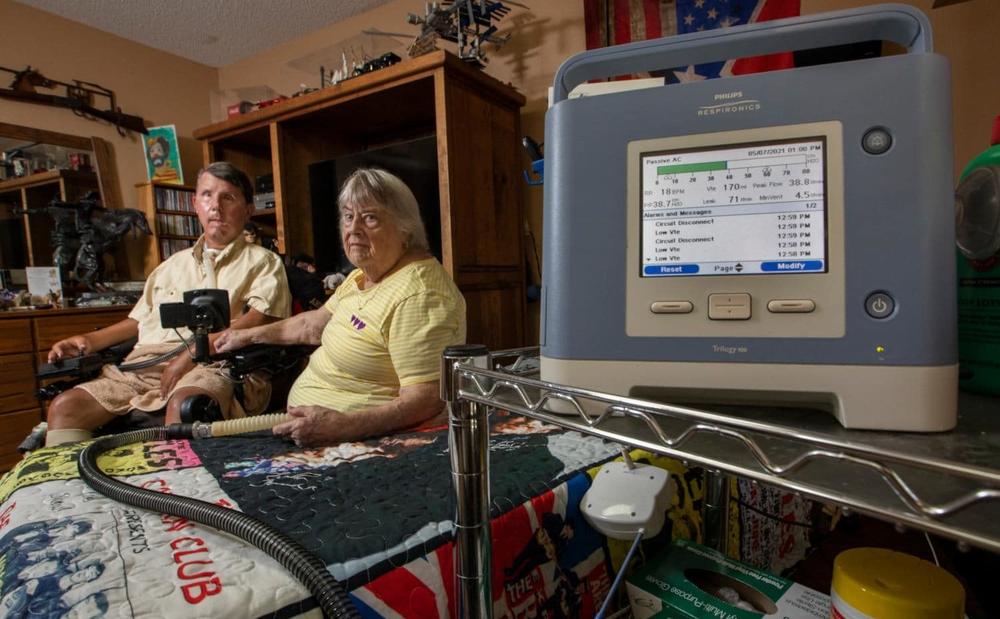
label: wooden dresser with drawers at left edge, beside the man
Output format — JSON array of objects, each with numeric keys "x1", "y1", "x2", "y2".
[{"x1": 0, "y1": 307, "x2": 129, "y2": 472}]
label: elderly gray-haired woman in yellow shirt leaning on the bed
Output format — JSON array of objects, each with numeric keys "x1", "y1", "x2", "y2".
[{"x1": 215, "y1": 169, "x2": 465, "y2": 445}]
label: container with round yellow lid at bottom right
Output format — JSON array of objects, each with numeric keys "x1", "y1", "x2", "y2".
[{"x1": 830, "y1": 548, "x2": 965, "y2": 619}]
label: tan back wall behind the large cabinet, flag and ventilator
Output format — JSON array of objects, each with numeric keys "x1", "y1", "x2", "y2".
[{"x1": 219, "y1": 0, "x2": 1000, "y2": 344}]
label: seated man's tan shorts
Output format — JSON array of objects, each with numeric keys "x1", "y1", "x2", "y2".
[{"x1": 75, "y1": 344, "x2": 271, "y2": 419}]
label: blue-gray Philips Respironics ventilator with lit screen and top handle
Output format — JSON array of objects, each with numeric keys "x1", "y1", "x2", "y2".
[{"x1": 541, "y1": 5, "x2": 958, "y2": 431}]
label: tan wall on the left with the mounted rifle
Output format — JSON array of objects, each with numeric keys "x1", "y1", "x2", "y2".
[{"x1": 0, "y1": 0, "x2": 218, "y2": 207}]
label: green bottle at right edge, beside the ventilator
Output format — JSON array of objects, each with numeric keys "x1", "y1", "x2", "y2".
[{"x1": 955, "y1": 116, "x2": 1000, "y2": 394}]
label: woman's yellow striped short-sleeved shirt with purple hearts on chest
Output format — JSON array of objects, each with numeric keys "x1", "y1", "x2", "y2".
[{"x1": 288, "y1": 258, "x2": 465, "y2": 411}]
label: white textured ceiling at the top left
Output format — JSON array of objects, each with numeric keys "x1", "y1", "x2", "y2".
[{"x1": 16, "y1": 0, "x2": 402, "y2": 67}]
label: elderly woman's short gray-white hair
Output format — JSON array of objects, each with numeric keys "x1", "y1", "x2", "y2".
[{"x1": 337, "y1": 168, "x2": 430, "y2": 251}]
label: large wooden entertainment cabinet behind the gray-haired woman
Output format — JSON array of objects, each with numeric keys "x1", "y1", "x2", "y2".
[{"x1": 194, "y1": 51, "x2": 526, "y2": 349}]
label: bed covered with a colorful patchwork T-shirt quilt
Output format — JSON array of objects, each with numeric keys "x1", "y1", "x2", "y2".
[{"x1": 0, "y1": 413, "x2": 618, "y2": 617}]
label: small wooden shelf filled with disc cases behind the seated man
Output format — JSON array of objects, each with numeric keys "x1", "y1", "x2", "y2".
[{"x1": 135, "y1": 183, "x2": 201, "y2": 276}]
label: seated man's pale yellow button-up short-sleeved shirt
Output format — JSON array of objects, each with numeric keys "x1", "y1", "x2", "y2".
[{"x1": 129, "y1": 235, "x2": 291, "y2": 348}]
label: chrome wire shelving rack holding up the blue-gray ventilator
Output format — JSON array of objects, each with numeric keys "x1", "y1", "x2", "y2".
[{"x1": 442, "y1": 346, "x2": 1000, "y2": 617}]
